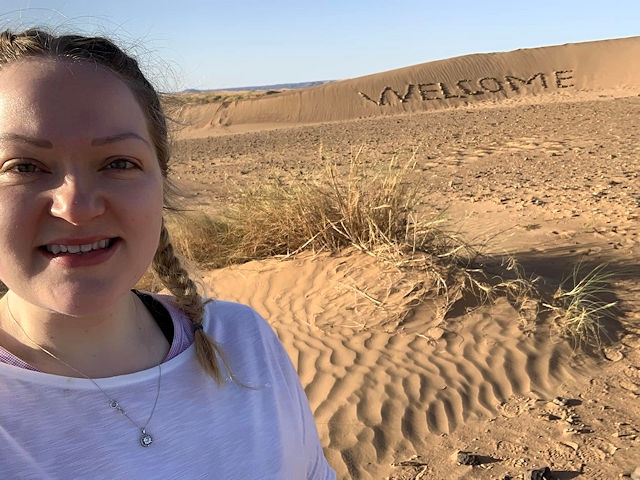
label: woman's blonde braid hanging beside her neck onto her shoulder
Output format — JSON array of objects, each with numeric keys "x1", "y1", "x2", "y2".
[{"x1": 152, "y1": 223, "x2": 230, "y2": 384}]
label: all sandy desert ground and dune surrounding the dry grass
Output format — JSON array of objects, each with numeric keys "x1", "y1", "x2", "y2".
[{"x1": 172, "y1": 37, "x2": 640, "y2": 480}]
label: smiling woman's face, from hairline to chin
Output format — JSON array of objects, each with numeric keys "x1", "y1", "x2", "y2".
[{"x1": 0, "y1": 59, "x2": 163, "y2": 315}]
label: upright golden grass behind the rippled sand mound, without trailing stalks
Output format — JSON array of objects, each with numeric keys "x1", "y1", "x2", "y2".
[{"x1": 162, "y1": 147, "x2": 476, "y2": 267}]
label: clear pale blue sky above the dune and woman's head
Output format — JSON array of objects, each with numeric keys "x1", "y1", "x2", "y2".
[{"x1": 0, "y1": 0, "x2": 640, "y2": 90}]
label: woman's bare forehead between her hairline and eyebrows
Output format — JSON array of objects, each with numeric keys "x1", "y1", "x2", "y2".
[{"x1": 0, "y1": 58, "x2": 148, "y2": 138}]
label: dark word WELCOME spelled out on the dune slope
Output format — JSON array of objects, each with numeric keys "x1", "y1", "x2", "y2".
[{"x1": 358, "y1": 70, "x2": 574, "y2": 106}]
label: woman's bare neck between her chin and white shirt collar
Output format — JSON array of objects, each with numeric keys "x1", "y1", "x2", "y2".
[{"x1": 0, "y1": 291, "x2": 169, "y2": 378}]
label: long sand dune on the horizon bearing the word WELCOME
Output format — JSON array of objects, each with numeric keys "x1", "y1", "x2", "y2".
[{"x1": 180, "y1": 37, "x2": 640, "y2": 138}]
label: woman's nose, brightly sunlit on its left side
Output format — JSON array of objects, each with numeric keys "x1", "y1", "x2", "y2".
[{"x1": 50, "y1": 176, "x2": 105, "y2": 225}]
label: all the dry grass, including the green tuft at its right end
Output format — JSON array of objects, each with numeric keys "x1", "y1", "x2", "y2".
[{"x1": 145, "y1": 149, "x2": 613, "y2": 347}]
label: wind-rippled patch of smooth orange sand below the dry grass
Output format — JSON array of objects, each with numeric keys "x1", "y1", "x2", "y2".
[{"x1": 206, "y1": 253, "x2": 575, "y2": 478}]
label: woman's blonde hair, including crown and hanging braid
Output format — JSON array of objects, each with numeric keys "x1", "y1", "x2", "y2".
[{"x1": 0, "y1": 29, "x2": 231, "y2": 383}]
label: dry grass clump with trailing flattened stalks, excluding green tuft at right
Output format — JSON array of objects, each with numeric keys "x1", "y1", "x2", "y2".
[{"x1": 154, "y1": 152, "x2": 531, "y2": 318}]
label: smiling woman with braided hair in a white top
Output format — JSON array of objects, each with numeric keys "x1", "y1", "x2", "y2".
[{"x1": 0, "y1": 30, "x2": 335, "y2": 479}]
